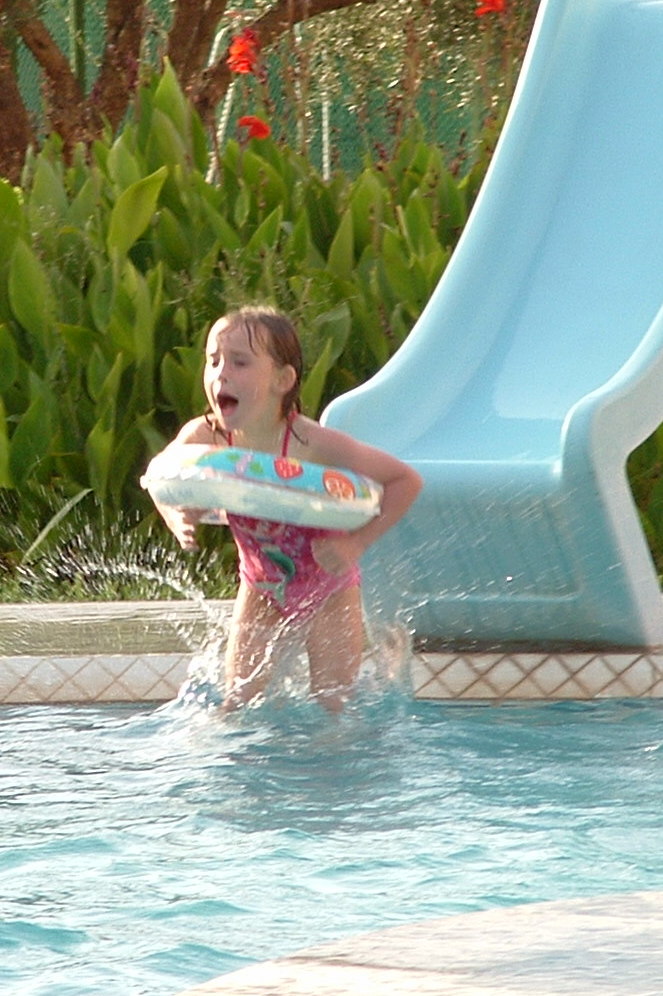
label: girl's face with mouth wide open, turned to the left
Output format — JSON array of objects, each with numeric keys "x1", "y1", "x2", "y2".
[{"x1": 203, "y1": 318, "x2": 294, "y2": 430}]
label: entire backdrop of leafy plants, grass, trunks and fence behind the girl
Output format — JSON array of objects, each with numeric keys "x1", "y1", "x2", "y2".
[{"x1": 6, "y1": 0, "x2": 663, "y2": 598}]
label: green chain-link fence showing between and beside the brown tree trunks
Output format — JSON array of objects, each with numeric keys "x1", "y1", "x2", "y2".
[{"x1": 15, "y1": 0, "x2": 536, "y2": 175}]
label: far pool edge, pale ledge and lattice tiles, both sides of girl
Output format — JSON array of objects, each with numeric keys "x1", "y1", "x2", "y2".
[{"x1": 0, "y1": 600, "x2": 663, "y2": 705}]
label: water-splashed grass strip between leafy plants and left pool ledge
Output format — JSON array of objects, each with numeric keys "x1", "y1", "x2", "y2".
[{"x1": 0, "y1": 488, "x2": 236, "y2": 603}]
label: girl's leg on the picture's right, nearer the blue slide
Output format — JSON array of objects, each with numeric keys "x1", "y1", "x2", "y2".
[{"x1": 306, "y1": 586, "x2": 364, "y2": 712}]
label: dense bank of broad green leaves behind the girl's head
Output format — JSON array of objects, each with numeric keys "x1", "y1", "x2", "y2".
[{"x1": 0, "y1": 64, "x2": 478, "y2": 531}]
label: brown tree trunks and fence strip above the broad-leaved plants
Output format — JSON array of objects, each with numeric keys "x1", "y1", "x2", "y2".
[{"x1": 0, "y1": 0, "x2": 536, "y2": 182}]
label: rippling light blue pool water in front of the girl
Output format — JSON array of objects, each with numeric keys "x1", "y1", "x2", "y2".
[{"x1": 0, "y1": 690, "x2": 663, "y2": 996}]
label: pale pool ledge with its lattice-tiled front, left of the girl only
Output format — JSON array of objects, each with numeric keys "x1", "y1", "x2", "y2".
[{"x1": 0, "y1": 600, "x2": 233, "y2": 705}]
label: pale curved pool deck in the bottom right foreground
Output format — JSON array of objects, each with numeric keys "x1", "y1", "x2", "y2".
[{"x1": 179, "y1": 892, "x2": 663, "y2": 996}]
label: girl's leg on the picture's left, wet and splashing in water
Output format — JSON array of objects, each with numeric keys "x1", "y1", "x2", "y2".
[{"x1": 223, "y1": 583, "x2": 283, "y2": 711}]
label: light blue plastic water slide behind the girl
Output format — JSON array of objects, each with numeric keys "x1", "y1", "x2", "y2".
[{"x1": 323, "y1": 0, "x2": 663, "y2": 647}]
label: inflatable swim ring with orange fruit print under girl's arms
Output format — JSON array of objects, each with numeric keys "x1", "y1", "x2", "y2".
[{"x1": 140, "y1": 443, "x2": 382, "y2": 529}]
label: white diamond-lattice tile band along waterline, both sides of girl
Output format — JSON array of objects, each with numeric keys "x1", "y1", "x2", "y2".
[{"x1": 0, "y1": 651, "x2": 663, "y2": 705}]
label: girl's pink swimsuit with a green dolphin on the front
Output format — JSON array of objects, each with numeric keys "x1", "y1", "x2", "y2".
[{"x1": 228, "y1": 422, "x2": 361, "y2": 622}]
